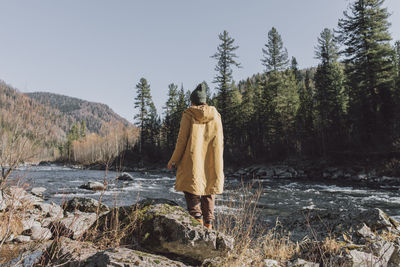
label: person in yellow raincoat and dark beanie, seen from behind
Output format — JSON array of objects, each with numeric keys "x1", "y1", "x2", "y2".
[{"x1": 168, "y1": 84, "x2": 224, "y2": 229}]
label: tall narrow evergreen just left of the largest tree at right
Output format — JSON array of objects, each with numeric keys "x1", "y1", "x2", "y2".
[{"x1": 314, "y1": 28, "x2": 347, "y2": 154}]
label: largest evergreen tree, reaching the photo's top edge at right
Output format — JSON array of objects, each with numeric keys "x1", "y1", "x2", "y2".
[{"x1": 338, "y1": 0, "x2": 393, "y2": 147}]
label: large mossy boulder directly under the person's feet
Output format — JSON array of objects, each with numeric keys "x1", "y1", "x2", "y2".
[{"x1": 134, "y1": 200, "x2": 234, "y2": 262}]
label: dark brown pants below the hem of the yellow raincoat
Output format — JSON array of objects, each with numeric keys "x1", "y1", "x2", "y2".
[{"x1": 184, "y1": 192, "x2": 215, "y2": 222}]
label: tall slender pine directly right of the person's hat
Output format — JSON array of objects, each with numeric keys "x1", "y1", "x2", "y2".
[{"x1": 212, "y1": 31, "x2": 240, "y2": 124}]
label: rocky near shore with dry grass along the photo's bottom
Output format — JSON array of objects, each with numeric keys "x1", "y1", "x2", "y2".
[{"x1": 0, "y1": 185, "x2": 400, "y2": 266}]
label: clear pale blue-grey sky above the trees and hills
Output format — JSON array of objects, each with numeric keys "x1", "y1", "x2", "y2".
[{"x1": 0, "y1": 0, "x2": 400, "y2": 121}]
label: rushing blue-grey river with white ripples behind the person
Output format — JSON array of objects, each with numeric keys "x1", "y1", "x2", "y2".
[{"x1": 12, "y1": 165, "x2": 400, "y2": 222}]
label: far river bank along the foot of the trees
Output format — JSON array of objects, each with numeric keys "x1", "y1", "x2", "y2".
[{"x1": 38, "y1": 157, "x2": 400, "y2": 187}]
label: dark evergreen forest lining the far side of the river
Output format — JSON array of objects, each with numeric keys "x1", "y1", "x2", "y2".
[{"x1": 135, "y1": 0, "x2": 400, "y2": 166}]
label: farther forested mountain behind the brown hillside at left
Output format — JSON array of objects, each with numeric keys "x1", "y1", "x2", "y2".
[{"x1": 26, "y1": 92, "x2": 131, "y2": 133}]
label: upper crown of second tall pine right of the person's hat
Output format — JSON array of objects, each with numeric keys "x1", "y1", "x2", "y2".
[{"x1": 261, "y1": 27, "x2": 289, "y2": 72}]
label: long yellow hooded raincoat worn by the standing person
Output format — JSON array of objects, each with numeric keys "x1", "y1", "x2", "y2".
[{"x1": 168, "y1": 105, "x2": 224, "y2": 196}]
